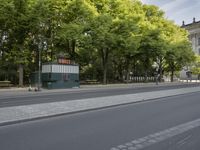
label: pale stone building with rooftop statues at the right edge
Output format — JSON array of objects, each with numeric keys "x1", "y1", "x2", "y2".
[{"x1": 182, "y1": 18, "x2": 200, "y2": 55}]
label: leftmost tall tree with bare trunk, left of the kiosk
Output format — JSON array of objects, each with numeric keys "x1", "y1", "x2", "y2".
[{"x1": 9, "y1": 0, "x2": 30, "y2": 86}]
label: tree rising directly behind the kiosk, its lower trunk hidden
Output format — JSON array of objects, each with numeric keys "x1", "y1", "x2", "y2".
[{"x1": 57, "y1": 0, "x2": 96, "y2": 61}]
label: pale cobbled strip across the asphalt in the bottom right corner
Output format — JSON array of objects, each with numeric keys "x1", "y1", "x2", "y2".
[{"x1": 110, "y1": 119, "x2": 200, "y2": 150}]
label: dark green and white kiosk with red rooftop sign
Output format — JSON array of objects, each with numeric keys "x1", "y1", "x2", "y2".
[{"x1": 42, "y1": 59, "x2": 80, "y2": 89}]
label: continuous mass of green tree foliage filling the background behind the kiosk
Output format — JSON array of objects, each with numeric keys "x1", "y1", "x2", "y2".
[{"x1": 0, "y1": 0, "x2": 195, "y2": 83}]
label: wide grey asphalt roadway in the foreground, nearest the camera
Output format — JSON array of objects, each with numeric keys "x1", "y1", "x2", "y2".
[{"x1": 0, "y1": 92, "x2": 200, "y2": 150}]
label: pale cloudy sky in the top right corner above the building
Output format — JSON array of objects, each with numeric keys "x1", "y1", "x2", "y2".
[{"x1": 141, "y1": 0, "x2": 200, "y2": 25}]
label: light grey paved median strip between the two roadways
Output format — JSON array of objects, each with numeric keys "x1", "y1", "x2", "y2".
[{"x1": 0, "y1": 87, "x2": 200, "y2": 126}]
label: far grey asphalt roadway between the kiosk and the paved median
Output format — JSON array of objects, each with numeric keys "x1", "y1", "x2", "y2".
[{"x1": 0, "y1": 83, "x2": 199, "y2": 107}]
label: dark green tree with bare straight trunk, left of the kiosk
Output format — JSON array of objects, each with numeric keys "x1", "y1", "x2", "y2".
[{"x1": 0, "y1": 0, "x2": 33, "y2": 86}]
